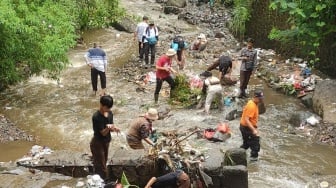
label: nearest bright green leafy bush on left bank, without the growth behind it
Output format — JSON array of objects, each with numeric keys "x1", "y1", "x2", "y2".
[{"x1": 0, "y1": 0, "x2": 76, "y2": 85}]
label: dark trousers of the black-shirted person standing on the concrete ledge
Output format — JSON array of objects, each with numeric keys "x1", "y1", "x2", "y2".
[{"x1": 90, "y1": 137, "x2": 110, "y2": 180}]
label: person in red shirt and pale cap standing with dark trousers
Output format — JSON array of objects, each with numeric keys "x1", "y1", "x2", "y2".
[{"x1": 154, "y1": 48, "x2": 176, "y2": 103}]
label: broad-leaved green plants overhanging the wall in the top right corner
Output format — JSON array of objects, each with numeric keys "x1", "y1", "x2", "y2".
[{"x1": 269, "y1": 0, "x2": 336, "y2": 66}]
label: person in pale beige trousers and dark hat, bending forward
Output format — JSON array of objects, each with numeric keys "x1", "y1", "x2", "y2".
[{"x1": 200, "y1": 71, "x2": 223, "y2": 114}]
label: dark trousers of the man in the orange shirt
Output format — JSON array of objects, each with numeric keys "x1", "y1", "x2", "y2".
[{"x1": 239, "y1": 125, "x2": 260, "y2": 157}]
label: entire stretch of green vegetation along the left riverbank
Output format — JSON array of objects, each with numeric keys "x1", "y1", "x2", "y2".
[{"x1": 0, "y1": 0, "x2": 124, "y2": 90}]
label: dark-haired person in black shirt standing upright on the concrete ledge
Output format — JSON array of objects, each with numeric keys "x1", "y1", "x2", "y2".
[{"x1": 90, "y1": 95, "x2": 120, "y2": 179}]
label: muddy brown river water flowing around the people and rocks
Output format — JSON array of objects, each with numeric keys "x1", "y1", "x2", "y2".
[{"x1": 0, "y1": 0, "x2": 336, "y2": 188}]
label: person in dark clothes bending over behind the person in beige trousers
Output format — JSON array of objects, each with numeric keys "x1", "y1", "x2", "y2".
[{"x1": 206, "y1": 54, "x2": 237, "y2": 85}]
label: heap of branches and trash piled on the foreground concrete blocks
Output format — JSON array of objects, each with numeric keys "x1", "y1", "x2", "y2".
[{"x1": 148, "y1": 122, "x2": 231, "y2": 186}]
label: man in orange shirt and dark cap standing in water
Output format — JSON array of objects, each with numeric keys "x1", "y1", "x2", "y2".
[{"x1": 239, "y1": 90, "x2": 264, "y2": 161}]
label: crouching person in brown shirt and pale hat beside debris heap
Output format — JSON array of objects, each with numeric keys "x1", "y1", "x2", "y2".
[{"x1": 126, "y1": 108, "x2": 159, "y2": 149}]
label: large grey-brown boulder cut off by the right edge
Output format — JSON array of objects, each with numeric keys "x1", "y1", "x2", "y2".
[{"x1": 313, "y1": 80, "x2": 336, "y2": 124}]
